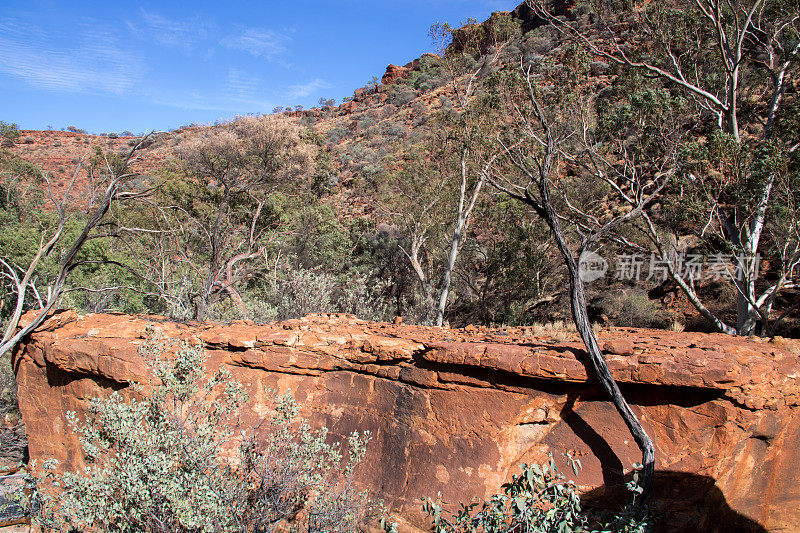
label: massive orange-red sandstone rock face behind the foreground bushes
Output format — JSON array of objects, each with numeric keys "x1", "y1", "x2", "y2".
[{"x1": 10, "y1": 312, "x2": 800, "y2": 532}]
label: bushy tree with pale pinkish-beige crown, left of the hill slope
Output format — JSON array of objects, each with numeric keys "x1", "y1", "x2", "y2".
[{"x1": 167, "y1": 115, "x2": 312, "y2": 320}]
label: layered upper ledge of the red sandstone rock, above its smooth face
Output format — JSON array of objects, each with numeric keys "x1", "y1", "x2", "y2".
[{"x1": 14, "y1": 310, "x2": 800, "y2": 410}]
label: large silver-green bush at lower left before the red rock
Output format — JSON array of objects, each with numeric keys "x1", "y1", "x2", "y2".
[{"x1": 32, "y1": 337, "x2": 375, "y2": 533}]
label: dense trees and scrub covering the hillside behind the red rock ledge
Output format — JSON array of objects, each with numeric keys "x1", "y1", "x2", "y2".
[{"x1": 0, "y1": 0, "x2": 800, "y2": 334}]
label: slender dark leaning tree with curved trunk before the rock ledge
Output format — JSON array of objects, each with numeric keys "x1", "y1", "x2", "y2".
[{"x1": 487, "y1": 47, "x2": 671, "y2": 503}]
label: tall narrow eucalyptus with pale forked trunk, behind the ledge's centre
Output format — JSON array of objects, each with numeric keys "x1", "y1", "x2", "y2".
[{"x1": 386, "y1": 15, "x2": 519, "y2": 326}]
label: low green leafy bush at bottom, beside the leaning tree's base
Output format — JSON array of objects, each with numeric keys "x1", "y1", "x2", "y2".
[{"x1": 422, "y1": 454, "x2": 652, "y2": 533}]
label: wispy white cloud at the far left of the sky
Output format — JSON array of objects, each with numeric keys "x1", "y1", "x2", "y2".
[{"x1": 0, "y1": 19, "x2": 144, "y2": 94}]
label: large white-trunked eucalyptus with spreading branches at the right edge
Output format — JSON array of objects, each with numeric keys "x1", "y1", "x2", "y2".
[{"x1": 529, "y1": 0, "x2": 800, "y2": 335}]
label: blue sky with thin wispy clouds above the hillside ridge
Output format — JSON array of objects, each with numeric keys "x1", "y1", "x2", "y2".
[{"x1": 0, "y1": 0, "x2": 521, "y2": 133}]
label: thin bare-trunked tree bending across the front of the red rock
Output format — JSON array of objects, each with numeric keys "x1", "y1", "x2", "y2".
[{"x1": 489, "y1": 57, "x2": 670, "y2": 502}]
